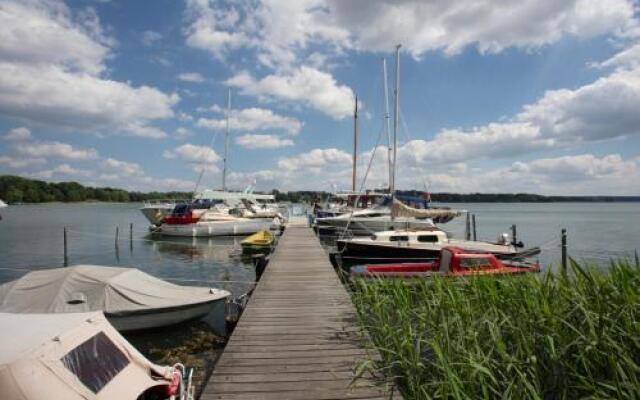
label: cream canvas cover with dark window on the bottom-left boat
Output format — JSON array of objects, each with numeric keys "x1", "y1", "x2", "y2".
[{"x1": 0, "y1": 312, "x2": 171, "y2": 400}]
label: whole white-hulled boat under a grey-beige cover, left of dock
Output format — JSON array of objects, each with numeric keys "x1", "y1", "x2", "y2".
[{"x1": 0, "y1": 265, "x2": 231, "y2": 331}]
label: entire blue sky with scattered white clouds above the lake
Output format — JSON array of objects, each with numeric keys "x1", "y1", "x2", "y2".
[{"x1": 0, "y1": 0, "x2": 640, "y2": 195}]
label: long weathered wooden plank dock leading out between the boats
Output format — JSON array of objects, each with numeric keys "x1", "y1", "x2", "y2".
[{"x1": 201, "y1": 223, "x2": 401, "y2": 400}]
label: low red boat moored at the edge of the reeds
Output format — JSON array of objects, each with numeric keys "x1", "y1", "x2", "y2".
[{"x1": 350, "y1": 247, "x2": 540, "y2": 279}]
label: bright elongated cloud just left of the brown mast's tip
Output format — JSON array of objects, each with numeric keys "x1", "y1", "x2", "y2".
[{"x1": 226, "y1": 66, "x2": 355, "y2": 119}]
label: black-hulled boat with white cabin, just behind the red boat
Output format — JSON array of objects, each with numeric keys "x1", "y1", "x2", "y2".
[{"x1": 336, "y1": 229, "x2": 540, "y2": 264}]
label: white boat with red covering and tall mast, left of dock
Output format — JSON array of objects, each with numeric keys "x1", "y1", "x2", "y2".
[{"x1": 154, "y1": 89, "x2": 284, "y2": 237}]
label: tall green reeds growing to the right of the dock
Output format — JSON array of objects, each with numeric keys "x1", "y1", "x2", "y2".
[{"x1": 354, "y1": 260, "x2": 640, "y2": 399}]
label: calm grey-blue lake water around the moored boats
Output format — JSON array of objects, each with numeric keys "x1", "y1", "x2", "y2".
[{"x1": 0, "y1": 203, "x2": 640, "y2": 394}]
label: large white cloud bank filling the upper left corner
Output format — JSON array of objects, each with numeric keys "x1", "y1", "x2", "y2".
[{"x1": 0, "y1": 0, "x2": 179, "y2": 138}]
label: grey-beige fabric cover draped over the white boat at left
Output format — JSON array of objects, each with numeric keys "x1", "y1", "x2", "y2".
[{"x1": 0, "y1": 265, "x2": 230, "y2": 315}]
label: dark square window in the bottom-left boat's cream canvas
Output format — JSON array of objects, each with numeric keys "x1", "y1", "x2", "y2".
[{"x1": 60, "y1": 332, "x2": 129, "y2": 393}]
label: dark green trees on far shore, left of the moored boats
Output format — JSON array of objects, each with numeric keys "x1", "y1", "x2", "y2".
[{"x1": 0, "y1": 175, "x2": 191, "y2": 203}]
